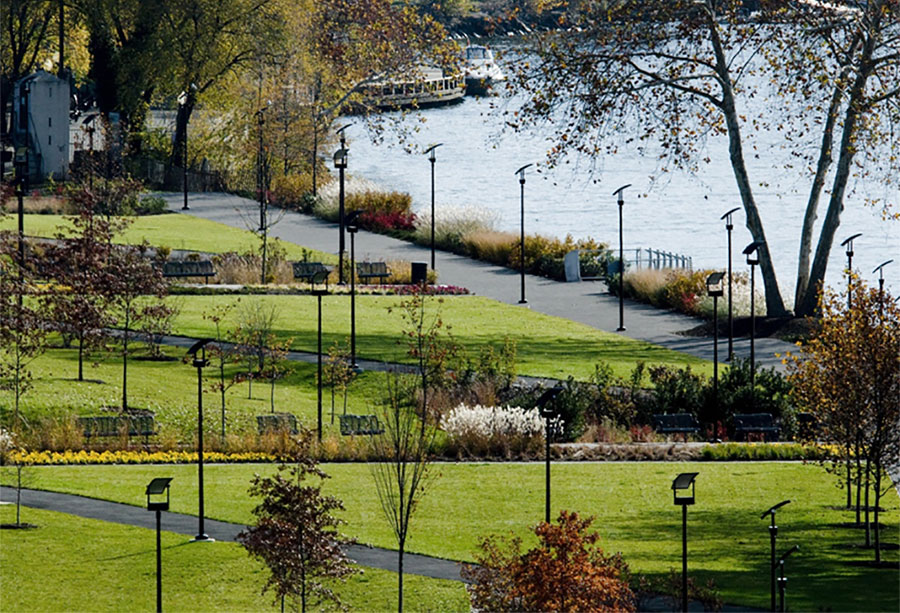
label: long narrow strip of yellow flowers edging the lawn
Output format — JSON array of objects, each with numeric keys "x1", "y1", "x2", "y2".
[{"x1": 9, "y1": 451, "x2": 279, "y2": 465}]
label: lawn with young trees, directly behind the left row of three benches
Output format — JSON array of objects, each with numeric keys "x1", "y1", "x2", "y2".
[{"x1": 12, "y1": 344, "x2": 385, "y2": 440}]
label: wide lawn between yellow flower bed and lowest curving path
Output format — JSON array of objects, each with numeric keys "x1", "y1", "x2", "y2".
[{"x1": 5, "y1": 462, "x2": 900, "y2": 611}]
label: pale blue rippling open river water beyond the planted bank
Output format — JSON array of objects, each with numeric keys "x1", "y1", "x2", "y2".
[{"x1": 347, "y1": 76, "x2": 900, "y2": 304}]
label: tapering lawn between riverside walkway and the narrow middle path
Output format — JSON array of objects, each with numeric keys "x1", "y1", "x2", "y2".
[{"x1": 173, "y1": 295, "x2": 712, "y2": 379}]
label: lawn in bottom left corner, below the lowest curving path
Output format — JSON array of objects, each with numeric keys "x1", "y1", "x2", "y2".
[{"x1": 0, "y1": 506, "x2": 469, "y2": 611}]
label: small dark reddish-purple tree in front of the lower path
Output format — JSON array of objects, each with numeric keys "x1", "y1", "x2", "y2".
[{"x1": 238, "y1": 430, "x2": 356, "y2": 612}]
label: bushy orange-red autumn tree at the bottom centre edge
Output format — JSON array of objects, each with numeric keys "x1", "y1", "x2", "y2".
[{"x1": 463, "y1": 510, "x2": 636, "y2": 613}]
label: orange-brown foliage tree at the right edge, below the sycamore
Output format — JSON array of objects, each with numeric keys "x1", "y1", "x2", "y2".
[{"x1": 788, "y1": 280, "x2": 900, "y2": 562}]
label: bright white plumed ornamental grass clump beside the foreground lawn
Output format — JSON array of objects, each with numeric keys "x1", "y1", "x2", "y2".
[{"x1": 441, "y1": 404, "x2": 544, "y2": 458}]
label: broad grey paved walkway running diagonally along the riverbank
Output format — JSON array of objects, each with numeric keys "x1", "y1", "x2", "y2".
[{"x1": 162, "y1": 193, "x2": 792, "y2": 369}]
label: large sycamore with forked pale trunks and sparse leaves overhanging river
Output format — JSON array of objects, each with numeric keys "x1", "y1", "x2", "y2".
[{"x1": 510, "y1": 0, "x2": 900, "y2": 315}]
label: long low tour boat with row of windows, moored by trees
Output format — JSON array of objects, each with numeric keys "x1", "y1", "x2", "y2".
[{"x1": 361, "y1": 66, "x2": 466, "y2": 110}]
